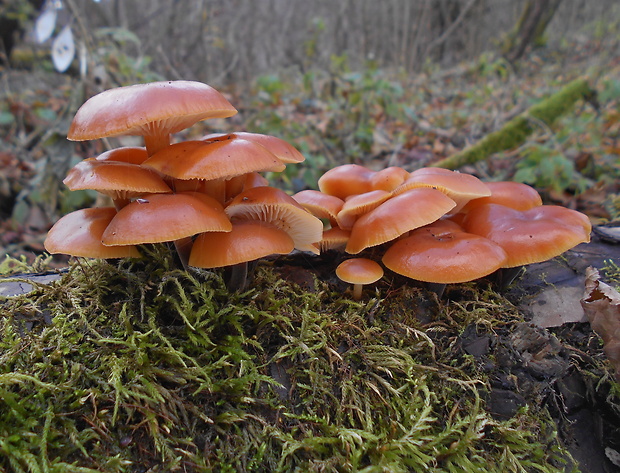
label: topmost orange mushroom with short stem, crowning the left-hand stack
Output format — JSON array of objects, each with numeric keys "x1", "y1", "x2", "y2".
[{"x1": 67, "y1": 80, "x2": 237, "y2": 155}]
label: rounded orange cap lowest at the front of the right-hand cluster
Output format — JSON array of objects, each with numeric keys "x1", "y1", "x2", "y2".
[{"x1": 383, "y1": 223, "x2": 507, "y2": 284}]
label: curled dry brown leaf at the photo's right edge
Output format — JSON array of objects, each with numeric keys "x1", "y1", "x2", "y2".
[{"x1": 581, "y1": 267, "x2": 620, "y2": 381}]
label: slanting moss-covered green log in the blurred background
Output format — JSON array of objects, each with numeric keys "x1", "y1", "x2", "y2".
[{"x1": 434, "y1": 79, "x2": 594, "y2": 169}]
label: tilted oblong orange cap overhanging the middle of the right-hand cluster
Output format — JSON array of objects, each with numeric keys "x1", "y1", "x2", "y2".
[{"x1": 346, "y1": 187, "x2": 455, "y2": 254}]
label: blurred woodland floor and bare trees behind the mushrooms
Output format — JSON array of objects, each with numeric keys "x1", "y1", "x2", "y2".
[{"x1": 0, "y1": 0, "x2": 620, "y2": 253}]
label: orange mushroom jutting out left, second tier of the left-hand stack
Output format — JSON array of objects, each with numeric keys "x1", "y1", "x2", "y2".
[{"x1": 62, "y1": 158, "x2": 172, "y2": 210}]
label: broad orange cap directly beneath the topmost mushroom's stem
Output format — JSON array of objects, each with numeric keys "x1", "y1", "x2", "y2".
[{"x1": 142, "y1": 138, "x2": 285, "y2": 181}]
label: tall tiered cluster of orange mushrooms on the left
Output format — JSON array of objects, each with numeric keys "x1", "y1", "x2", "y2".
[{"x1": 45, "y1": 81, "x2": 323, "y2": 284}]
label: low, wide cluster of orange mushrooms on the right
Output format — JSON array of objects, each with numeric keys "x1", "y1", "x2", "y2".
[{"x1": 293, "y1": 164, "x2": 591, "y2": 295}]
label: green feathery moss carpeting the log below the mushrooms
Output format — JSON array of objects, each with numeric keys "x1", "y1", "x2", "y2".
[{"x1": 0, "y1": 253, "x2": 564, "y2": 472}]
